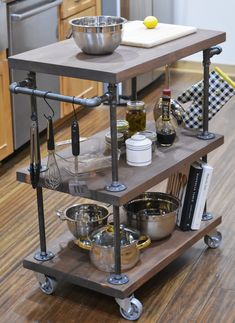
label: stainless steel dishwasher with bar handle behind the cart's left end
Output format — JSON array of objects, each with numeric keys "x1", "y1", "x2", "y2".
[{"x1": 7, "y1": 0, "x2": 62, "y2": 149}]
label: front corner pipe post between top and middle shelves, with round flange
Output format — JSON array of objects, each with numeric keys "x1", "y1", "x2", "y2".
[{"x1": 105, "y1": 84, "x2": 126, "y2": 192}]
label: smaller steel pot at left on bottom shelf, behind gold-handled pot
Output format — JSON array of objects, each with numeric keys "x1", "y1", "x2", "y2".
[{"x1": 56, "y1": 204, "x2": 110, "y2": 239}]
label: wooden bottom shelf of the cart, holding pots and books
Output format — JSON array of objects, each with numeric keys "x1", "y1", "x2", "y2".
[{"x1": 23, "y1": 217, "x2": 222, "y2": 298}]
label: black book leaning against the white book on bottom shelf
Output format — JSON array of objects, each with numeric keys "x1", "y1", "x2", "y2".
[{"x1": 180, "y1": 165, "x2": 202, "y2": 231}]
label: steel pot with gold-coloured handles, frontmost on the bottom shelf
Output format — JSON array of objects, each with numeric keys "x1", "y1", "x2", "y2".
[{"x1": 77, "y1": 225, "x2": 151, "y2": 272}]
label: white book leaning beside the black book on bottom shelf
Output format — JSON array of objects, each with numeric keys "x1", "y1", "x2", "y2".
[{"x1": 191, "y1": 164, "x2": 213, "y2": 230}]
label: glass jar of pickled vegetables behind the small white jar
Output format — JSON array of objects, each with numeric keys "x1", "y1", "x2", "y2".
[{"x1": 126, "y1": 101, "x2": 146, "y2": 136}]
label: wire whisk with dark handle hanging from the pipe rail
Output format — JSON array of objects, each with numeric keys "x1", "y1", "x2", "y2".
[{"x1": 44, "y1": 116, "x2": 61, "y2": 190}]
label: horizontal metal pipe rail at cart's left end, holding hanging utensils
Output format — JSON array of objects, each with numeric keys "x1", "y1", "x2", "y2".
[{"x1": 10, "y1": 82, "x2": 112, "y2": 108}]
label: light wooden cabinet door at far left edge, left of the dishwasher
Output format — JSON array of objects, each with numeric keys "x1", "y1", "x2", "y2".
[{"x1": 0, "y1": 51, "x2": 13, "y2": 160}]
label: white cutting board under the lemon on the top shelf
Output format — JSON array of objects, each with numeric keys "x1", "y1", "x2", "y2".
[{"x1": 121, "y1": 20, "x2": 197, "y2": 48}]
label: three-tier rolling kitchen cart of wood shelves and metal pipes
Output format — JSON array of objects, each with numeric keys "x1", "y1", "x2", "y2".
[{"x1": 9, "y1": 29, "x2": 225, "y2": 320}]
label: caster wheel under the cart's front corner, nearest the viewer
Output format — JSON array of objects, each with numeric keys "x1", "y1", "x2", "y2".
[{"x1": 116, "y1": 295, "x2": 143, "y2": 321}]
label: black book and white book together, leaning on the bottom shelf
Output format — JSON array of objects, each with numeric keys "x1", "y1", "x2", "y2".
[{"x1": 177, "y1": 161, "x2": 213, "y2": 231}]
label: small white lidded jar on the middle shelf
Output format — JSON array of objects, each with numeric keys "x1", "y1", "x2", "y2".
[{"x1": 125, "y1": 134, "x2": 152, "y2": 166}]
